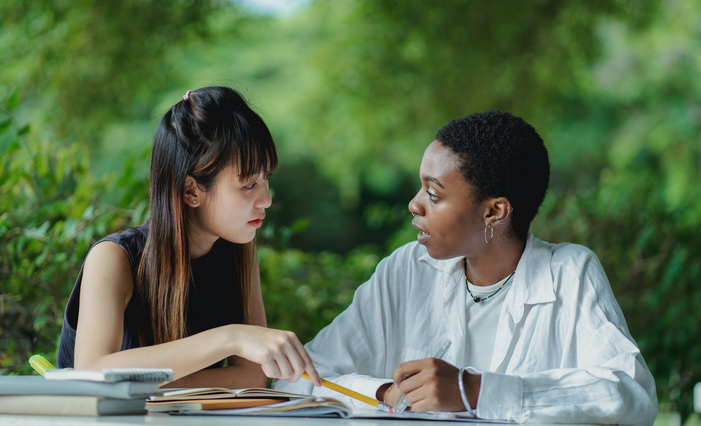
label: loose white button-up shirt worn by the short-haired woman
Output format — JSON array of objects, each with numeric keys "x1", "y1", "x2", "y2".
[{"x1": 274, "y1": 234, "x2": 657, "y2": 426}]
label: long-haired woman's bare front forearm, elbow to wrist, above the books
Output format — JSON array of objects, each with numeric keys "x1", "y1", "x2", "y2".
[{"x1": 75, "y1": 326, "x2": 236, "y2": 380}]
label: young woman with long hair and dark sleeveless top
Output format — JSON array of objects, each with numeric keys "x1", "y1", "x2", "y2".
[{"x1": 58, "y1": 87, "x2": 320, "y2": 388}]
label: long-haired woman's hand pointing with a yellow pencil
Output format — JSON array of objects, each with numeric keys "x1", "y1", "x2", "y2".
[{"x1": 229, "y1": 324, "x2": 321, "y2": 386}]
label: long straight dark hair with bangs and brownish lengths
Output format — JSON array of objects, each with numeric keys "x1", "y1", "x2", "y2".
[{"x1": 137, "y1": 87, "x2": 278, "y2": 345}]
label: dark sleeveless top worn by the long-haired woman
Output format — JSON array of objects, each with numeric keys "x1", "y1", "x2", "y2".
[{"x1": 58, "y1": 222, "x2": 243, "y2": 368}]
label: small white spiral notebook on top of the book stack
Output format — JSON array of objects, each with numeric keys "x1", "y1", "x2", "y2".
[{"x1": 44, "y1": 368, "x2": 173, "y2": 383}]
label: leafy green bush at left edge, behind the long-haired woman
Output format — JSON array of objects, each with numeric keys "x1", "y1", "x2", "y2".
[{"x1": 0, "y1": 107, "x2": 145, "y2": 371}]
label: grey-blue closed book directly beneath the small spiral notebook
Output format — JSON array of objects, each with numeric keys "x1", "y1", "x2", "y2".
[{"x1": 0, "y1": 376, "x2": 162, "y2": 399}]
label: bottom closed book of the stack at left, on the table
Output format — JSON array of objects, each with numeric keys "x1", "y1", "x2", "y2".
[{"x1": 0, "y1": 395, "x2": 146, "y2": 416}]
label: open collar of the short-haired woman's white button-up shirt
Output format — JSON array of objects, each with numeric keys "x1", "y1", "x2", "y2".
[{"x1": 419, "y1": 232, "x2": 555, "y2": 323}]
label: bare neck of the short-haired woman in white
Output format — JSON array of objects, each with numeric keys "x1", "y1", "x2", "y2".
[{"x1": 465, "y1": 239, "x2": 526, "y2": 286}]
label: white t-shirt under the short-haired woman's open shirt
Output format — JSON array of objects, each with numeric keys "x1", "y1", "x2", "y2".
[{"x1": 465, "y1": 276, "x2": 513, "y2": 371}]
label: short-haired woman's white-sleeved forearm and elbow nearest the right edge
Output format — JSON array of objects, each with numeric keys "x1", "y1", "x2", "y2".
[{"x1": 477, "y1": 323, "x2": 657, "y2": 426}]
